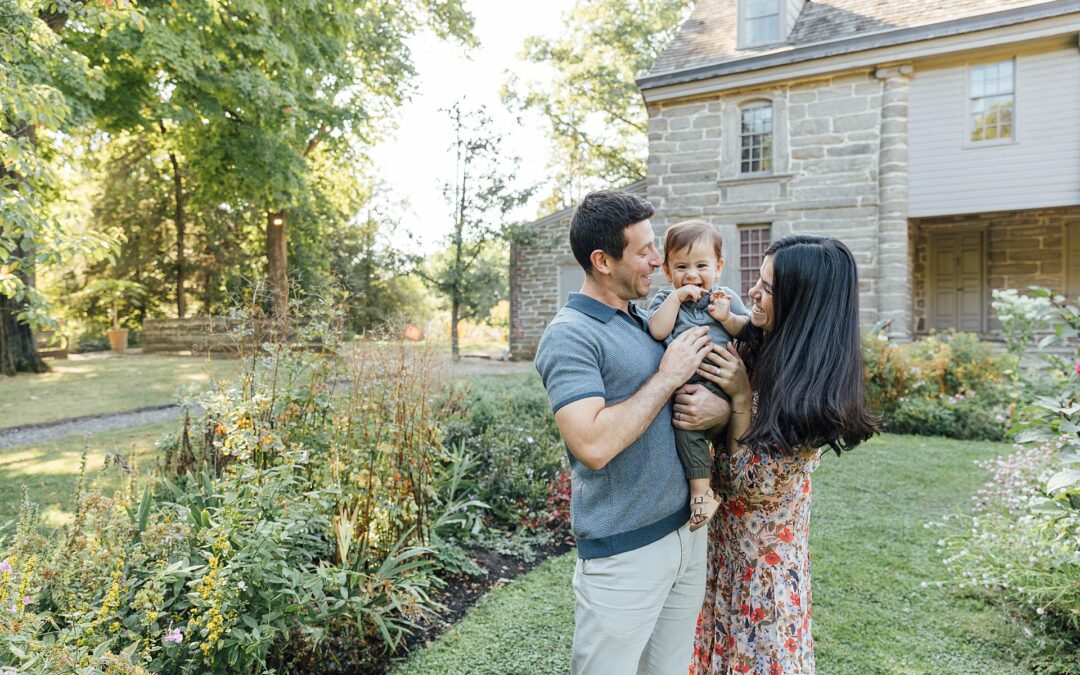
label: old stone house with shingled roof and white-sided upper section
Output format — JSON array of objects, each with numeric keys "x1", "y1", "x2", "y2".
[{"x1": 511, "y1": 0, "x2": 1080, "y2": 357}]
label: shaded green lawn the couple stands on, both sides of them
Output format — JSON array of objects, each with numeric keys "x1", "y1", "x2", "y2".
[{"x1": 394, "y1": 435, "x2": 1028, "y2": 675}]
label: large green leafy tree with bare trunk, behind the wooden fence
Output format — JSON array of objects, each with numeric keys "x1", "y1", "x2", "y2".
[{"x1": 78, "y1": 0, "x2": 473, "y2": 314}]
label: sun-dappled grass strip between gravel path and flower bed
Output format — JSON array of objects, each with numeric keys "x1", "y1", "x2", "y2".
[{"x1": 0, "y1": 421, "x2": 172, "y2": 527}]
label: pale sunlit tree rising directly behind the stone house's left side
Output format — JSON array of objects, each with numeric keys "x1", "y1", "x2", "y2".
[{"x1": 503, "y1": 0, "x2": 691, "y2": 210}]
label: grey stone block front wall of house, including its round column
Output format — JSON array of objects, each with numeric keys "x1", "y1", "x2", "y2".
[{"x1": 647, "y1": 66, "x2": 912, "y2": 337}]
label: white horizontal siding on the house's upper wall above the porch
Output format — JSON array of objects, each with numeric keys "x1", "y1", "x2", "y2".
[{"x1": 908, "y1": 46, "x2": 1080, "y2": 217}]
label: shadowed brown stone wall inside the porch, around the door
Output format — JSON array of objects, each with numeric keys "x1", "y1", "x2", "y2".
[{"x1": 912, "y1": 206, "x2": 1080, "y2": 334}]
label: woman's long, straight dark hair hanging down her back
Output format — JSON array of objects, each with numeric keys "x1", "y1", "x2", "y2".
[{"x1": 735, "y1": 234, "x2": 878, "y2": 455}]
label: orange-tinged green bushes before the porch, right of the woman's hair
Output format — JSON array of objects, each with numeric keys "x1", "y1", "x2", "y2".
[{"x1": 863, "y1": 330, "x2": 1018, "y2": 441}]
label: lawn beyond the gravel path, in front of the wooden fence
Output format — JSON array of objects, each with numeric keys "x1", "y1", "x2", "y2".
[{"x1": 0, "y1": 354, "x2": 240, "y2": 429}]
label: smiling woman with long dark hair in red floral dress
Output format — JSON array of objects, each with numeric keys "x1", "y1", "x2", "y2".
[{"x1": 675, "y1": 234, "x2": 877, "y2": 675}]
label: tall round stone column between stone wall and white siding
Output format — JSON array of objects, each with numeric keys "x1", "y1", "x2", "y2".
[{"x1": 874, "y1": 64, "x2": 914, "y2": 341}]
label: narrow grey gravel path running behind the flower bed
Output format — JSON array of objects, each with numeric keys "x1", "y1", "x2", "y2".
[{"x1": 0, "y1": 359, "x2": 532, "y2": 450}]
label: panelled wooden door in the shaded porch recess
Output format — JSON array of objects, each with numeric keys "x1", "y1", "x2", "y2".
[{"x1": 929, "y1": 230, "x2": 986, "y2": 333}]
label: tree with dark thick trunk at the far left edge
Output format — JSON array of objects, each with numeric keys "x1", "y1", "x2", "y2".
[{"x1": 0, "y1": 0, "x2": 122, "y2": 375}]
